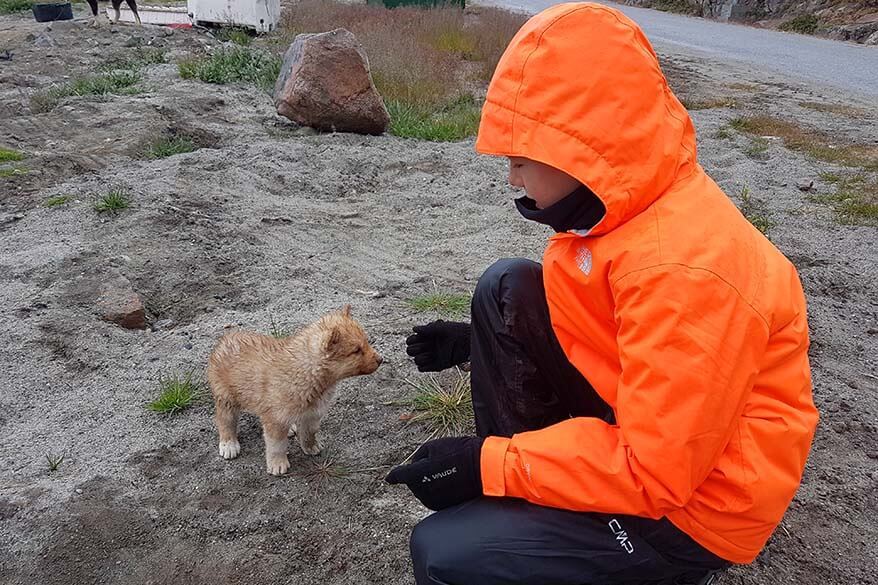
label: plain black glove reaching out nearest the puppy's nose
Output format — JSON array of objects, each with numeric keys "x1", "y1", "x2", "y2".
[{"x1": 405, "y1": 319, "x2": 470, "y2": 372}]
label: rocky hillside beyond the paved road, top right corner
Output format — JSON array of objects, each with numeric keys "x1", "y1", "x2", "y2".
[{"x1": 625, "y1": 0, "x2": 878, "y2": 45}]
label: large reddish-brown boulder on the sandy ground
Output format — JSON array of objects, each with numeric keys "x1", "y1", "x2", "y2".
[{"x1": 274, "y1": 28, "x2": 390, "y2": 134}]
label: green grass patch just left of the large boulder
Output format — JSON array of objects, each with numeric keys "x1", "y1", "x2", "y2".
[{"x1": 178, "y1": 47, "x2": 281, "y2": 91}]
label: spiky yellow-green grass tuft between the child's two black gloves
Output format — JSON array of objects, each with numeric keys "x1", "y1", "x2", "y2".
[{"x1": 406, "y1": 370, "x2": 474, "y2": 437}]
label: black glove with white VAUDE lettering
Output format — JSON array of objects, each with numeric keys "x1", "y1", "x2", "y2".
[{"x1": 386, "y1": 437, "x2": 485, "y2": 510}]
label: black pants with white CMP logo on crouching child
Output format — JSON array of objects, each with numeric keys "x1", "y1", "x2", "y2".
[{"x1": 411, "y1": 260, "x2": 728, "y2": 585}]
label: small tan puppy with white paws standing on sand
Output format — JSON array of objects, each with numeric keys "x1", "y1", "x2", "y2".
[{"x1": 207, "y1": 305, "x2": 382, "y2": 475}]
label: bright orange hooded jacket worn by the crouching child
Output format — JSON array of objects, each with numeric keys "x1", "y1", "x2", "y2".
[{"x1": 476, "y1": 3, "x2": 817, "y2": 563}]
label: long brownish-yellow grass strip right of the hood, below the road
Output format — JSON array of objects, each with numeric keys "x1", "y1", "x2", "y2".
[{"x1": 729, "y1": 115, "x2": 878, "y2": 171}]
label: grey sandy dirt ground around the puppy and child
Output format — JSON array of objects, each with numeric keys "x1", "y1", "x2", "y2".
[{"x1": 0, "y1": 9, "x2": 878, "y2": 585}]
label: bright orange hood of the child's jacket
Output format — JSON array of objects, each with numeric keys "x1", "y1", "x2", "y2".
[{"x1": 476, "y1": 3, "x2": 697, "y2": 235}]
